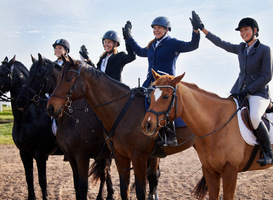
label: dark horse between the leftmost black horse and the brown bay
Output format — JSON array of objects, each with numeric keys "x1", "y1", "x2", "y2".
[{"x1": 17, "y1": 54, "x2": 114, "y2": 200}]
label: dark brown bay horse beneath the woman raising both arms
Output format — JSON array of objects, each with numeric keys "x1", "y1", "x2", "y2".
[{"x1": 47, "y1": 56, "x2": 195, "y2": 200}]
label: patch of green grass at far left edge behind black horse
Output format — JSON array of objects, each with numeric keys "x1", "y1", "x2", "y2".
[{"x1": 0, "y1": 106, "x2": 14, "y2": 145}]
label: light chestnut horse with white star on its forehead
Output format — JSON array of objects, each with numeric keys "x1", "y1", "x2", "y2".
[{"x1": 141, "y1": 71, "x2": 272, "y2": 200}]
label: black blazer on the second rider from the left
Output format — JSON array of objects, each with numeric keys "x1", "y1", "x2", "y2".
[{"x1": 97, "y1": 43, "x2": 136, "y2": 82}]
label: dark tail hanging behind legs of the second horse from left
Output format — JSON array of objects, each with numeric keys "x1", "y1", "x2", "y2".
[{"x1": 88, "y1": 159, "x2": 111, "y2": 184}]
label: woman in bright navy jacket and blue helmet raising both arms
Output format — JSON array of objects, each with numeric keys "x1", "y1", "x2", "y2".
[{"x1": 123, "y1": 16, "x2": 200, "y2": 146}]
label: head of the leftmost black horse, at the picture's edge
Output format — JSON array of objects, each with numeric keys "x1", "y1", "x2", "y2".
[{"x1": 0, "y1": 55, "x2": 15, "y2": 96}]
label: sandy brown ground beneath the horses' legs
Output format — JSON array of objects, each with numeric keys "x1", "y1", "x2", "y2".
[{"x1": 0, "y1": 145, "x2": 273, "y2": 200}]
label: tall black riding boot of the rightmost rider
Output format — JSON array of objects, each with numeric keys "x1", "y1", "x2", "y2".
[{"x1": 254, "y1": 122, "x2": 273, "y2": 166}]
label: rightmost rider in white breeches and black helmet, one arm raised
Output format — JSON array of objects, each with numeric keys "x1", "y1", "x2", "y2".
[{"x1": 193, "y1": 12, "x2": 273, "y2": 166}]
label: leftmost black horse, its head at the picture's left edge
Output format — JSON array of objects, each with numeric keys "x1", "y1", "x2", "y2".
[{"x1": 0, "y1": 56, "x2": 63, "y2": 200}]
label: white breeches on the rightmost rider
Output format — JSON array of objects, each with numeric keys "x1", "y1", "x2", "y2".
[{"x1": 247, "y1": 95, "x2": 270, "y2": 129}]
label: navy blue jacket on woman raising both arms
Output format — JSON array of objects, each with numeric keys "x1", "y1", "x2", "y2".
[{"x1": 126, "y1": 32, "x2": 200, "y2": 87}]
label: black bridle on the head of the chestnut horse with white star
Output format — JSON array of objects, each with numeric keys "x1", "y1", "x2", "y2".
[{"x1": 147, "y1": 85, "x2": 177, "y2": 127}]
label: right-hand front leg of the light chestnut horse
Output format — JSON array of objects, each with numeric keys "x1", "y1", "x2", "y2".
[{"x1": 222, "y1": 162, "x2": 238, "y2": 200}]
